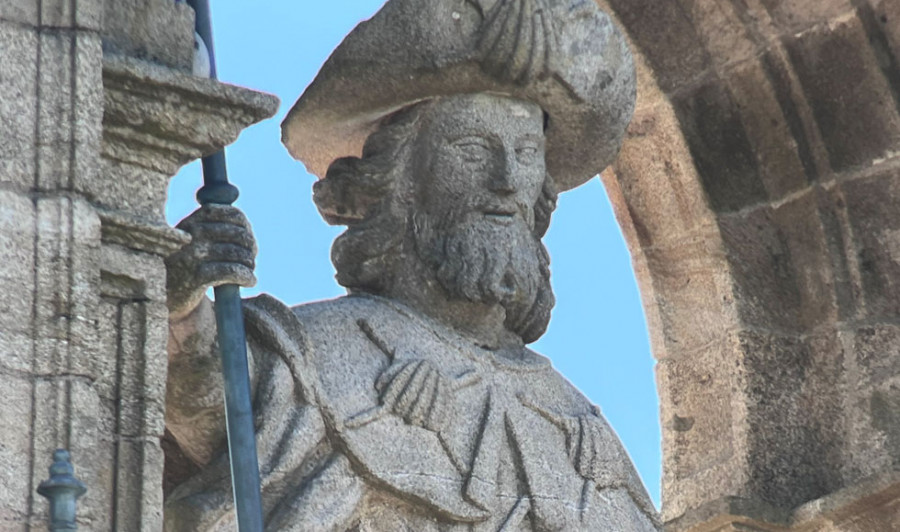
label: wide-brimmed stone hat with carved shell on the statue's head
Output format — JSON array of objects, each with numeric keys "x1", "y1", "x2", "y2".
[{"x1": 282, "y1": 0, "x2": 635, "y2": 190}]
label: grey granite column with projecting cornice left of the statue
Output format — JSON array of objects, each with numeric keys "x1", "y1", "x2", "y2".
[{"x1": 0, "y1": 0, "x2": 277, "y2": 530}]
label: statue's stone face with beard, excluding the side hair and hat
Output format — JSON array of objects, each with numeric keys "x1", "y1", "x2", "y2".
[{"x1": 412, "y1": 94, "x2": 546, "y2": 322}]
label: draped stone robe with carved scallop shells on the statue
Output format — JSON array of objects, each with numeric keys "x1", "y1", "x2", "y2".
[{"x1": 166, "y1": 295, "x2": 657, "y2": 532}]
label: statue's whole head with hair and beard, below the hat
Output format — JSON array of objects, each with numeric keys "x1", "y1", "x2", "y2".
[{"x1": 314, "y1": 94, "x2": 556, "y2": 342}]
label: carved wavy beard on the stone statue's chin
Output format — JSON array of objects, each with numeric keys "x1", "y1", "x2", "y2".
[{"x1": 412, "y1": 210, "x2": 543, "y2": 323}]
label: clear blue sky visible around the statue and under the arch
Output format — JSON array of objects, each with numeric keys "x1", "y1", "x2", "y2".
[{"x1": 167, "y1": 0, "x2": 661, "y2": 505}]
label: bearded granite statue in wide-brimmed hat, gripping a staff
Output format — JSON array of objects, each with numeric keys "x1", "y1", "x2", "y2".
[{"x1": 166, "y1": 0, "x2": 657, "y2": 532}]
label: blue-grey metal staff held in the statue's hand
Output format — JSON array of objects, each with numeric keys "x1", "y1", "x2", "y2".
[{"x1": 188, "y1": 0, "x2": 263, "y2": 532}]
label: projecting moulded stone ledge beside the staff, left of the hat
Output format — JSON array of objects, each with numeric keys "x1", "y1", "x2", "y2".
[{"x1": 103, "y1": 56, "x2": 279, "y2": 175}]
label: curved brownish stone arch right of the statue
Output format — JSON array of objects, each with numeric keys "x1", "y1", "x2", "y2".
[{"x1": 599, "y1": 0, "x2": 900, "y2": 530}]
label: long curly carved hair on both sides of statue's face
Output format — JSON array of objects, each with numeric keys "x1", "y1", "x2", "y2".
[{"x1": 313, "y1": 102, "x2": 557, "y2": 342}]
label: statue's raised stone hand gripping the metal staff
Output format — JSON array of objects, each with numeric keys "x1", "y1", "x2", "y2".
[{"x1": 166, "y1": 204, "x2": 256, "y2": 317}]
